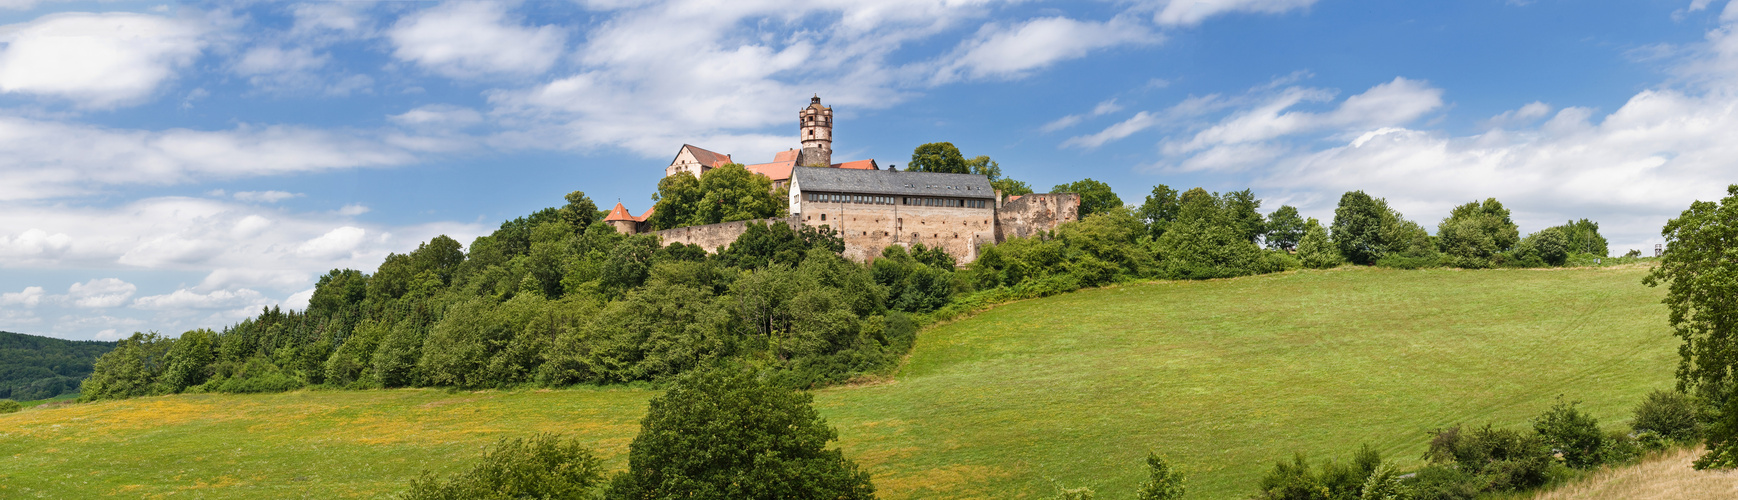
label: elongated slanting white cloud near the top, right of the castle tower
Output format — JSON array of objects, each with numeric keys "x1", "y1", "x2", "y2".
[{"x1": 935, "y1": 17, "x2": 1163, "y2": 82}]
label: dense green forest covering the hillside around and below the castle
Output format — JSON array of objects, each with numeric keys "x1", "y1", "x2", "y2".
[{"x1": 67, "y1": 164, "x2": 1608, "y2": 401}]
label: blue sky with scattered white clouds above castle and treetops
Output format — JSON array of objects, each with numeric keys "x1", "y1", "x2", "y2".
[{"x1": 0, "y1": 0, "x2": 1738, "y2": 340}]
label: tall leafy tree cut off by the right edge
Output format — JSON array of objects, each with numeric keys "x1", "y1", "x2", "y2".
[{"x1": 1642, "y1": 184, "x2": 1738, "y2": 469}]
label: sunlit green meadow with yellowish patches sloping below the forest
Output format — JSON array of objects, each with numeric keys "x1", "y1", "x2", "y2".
[{"x1": 0, "y1": 267, "x2": 1677, "y2": 498}]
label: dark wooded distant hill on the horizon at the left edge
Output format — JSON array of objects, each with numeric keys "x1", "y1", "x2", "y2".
[{"x1": 0, "y1": 332, "x2": 115, "y2": 401}]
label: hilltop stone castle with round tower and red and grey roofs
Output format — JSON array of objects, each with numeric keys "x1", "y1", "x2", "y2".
[{"x1": 603, "y1": 95, "x2": 1079, "y2": 264}]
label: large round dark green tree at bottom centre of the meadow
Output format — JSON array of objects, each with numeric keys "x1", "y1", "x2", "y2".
[{"x1": 607, "y1": 368, "x2": 874, "y2": 500}]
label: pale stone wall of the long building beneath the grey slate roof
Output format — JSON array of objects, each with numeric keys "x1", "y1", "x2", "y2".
[{"x1": 798, "y1": 201, "x2": 996, "y2": 264}]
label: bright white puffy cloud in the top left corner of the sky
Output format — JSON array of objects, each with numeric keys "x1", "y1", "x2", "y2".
[{"x1": 0, "y1": 12, "x2": 205, "y2": 108}]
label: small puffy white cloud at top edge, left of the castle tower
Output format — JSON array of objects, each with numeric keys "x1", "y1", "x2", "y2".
[{"x1": 389, "y1": 2, "x2": 567, "y2": 78}]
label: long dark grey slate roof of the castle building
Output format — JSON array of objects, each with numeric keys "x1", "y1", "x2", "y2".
[{"x1": 791, "y1": 167, "x2": 996, "y2": 200}]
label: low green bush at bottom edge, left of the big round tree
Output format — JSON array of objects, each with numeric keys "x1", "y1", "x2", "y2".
[{"x1": 400, "y1": 434, "x2": 603, "y2": 500}]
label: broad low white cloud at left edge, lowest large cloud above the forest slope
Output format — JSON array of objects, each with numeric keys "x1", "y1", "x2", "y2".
[{"x1": 0, "y1": 196, "x2": 487, "y2": 274}]
